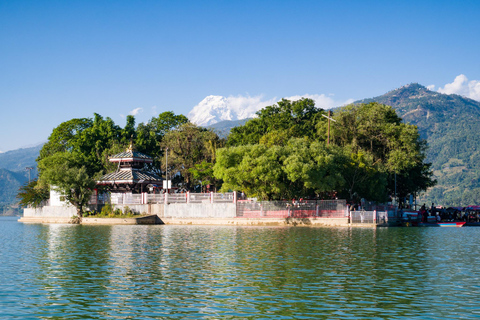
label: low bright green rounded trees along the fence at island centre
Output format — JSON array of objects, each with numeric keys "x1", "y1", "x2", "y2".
[{"x1": 214, "y1": 138, "x2": 345, "y2": 200}]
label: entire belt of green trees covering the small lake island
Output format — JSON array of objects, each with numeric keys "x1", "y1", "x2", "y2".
[{"x1": 20, "y1": 99, "x2": 435, "y2": 211}]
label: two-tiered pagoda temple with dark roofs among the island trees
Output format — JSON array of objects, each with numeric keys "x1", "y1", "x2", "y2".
[{"x1": 97, "y1": 142, "x2": 163, "y2": 194}]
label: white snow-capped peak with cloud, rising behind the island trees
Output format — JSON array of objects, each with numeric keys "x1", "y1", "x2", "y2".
[{"x1": 188, "y1": 95, "x2": 275, "y2": 126}]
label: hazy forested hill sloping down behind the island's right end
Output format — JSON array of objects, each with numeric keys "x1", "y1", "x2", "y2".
[{"x1": 355, "y1": 83, "x2": 480, "y2": 206}]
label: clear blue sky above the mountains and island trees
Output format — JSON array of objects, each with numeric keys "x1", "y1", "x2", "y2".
[{"x1": 0, "y1": 0, "x2": 480, "y2": 151}]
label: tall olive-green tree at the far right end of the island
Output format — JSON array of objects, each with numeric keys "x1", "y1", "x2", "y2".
[{"x1": 332, "y1": 102, "x2": 436, "y2": 198}]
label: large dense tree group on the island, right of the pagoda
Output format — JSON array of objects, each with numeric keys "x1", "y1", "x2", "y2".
[{"x1": 214, "y1": 99, "x2": 435, "y2": 201}]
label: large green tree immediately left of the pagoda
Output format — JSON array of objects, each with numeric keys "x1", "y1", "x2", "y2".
[{"x1": 37, "y1": 114, "x2": 141, "y2": 217}]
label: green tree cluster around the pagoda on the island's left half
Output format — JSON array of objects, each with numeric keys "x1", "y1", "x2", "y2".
[{"x1": 19, "y1": 112, "x2": 195, "y2": 216}]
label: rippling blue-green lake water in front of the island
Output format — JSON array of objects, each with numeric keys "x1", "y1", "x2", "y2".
[{"x1": 0, "y1": 218, "x2": 480, "y2": 319}]
